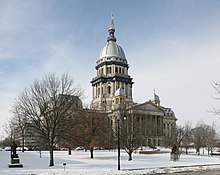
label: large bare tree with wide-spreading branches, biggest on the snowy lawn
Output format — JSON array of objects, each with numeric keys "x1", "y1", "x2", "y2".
[{"x1": 15, "y1": 74, "x2": 83, "y2": 166}]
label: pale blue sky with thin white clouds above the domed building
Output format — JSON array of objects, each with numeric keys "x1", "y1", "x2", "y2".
[{"x1": 0, "y1": 0, "x2": 220, "y2": 135}]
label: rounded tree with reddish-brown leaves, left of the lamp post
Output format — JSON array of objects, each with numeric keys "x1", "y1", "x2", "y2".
[{"x1": 72, "y1": 109, "x2": 108, "y2": 159}]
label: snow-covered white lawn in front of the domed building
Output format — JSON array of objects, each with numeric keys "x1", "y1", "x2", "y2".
[{"x1": 0, "y1": 150, "x2": 220, "y2": 175}]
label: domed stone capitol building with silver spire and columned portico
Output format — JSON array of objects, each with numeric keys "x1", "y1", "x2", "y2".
[{"x1": 91, "y1": 18, "x2": 177, "y2": 146}]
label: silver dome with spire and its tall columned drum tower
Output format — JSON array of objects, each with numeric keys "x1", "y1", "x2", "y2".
[{"x1": 91, "y1": 16, "x2": 134, "y2": 111}]
